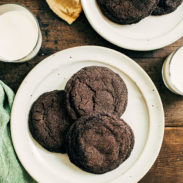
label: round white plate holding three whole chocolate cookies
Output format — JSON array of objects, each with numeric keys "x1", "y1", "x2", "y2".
[{"x1": 11, "y1": 46, "x2": 164, "y2": 183}]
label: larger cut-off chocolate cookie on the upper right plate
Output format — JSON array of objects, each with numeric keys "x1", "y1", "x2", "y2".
[{"x1": 97, "y1": 0, "x2": 159, "y2": 24}]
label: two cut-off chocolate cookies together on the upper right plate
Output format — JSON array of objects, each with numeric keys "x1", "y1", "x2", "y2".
[{"x1": 97, "y1": 0, "x2": 183, "y2": 24}]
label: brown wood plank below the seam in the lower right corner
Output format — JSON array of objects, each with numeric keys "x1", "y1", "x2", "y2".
[{"x1": 139, "y1": 127, "x2": 183, "y2": 183}]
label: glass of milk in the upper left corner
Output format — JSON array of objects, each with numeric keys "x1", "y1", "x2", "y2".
[{"x1": 0, "y1": 4, "x2": 42, "y2": 62}]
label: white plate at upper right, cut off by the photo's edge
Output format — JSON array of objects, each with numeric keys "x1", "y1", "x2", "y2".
[{"x1": 81, "y1": 0, "x2": 183, "y2": 51}]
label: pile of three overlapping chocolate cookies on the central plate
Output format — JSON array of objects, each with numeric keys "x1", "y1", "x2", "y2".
[{"x1": 29, "y1": 66, "x2": 134, "y2": 174}]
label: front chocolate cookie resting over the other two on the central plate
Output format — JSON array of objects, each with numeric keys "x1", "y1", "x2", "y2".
[{"x1": 66, "y1": 114, "x2": 134, "y2": 174}]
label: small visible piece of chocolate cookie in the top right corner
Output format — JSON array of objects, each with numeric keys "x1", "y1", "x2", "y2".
[{"x1": 152, "y1": 0, "x2": 183, "y2": 15}]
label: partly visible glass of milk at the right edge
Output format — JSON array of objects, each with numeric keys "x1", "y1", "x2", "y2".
[{"x1": 162, "y1": 46, "x2": 183, "y2": 96}]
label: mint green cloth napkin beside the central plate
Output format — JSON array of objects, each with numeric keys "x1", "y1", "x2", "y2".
[{"x1": 0, "y1": 80, "x2": 35, "y2": 183}]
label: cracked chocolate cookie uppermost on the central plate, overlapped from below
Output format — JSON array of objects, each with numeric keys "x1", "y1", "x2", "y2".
[{"x1": 65, "y1": 66, "x2": 128, "y2": 120}]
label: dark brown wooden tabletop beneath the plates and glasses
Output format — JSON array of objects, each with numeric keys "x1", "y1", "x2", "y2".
[{"x1": 0, "y1": 0, "x2": 183, "y2": 183}]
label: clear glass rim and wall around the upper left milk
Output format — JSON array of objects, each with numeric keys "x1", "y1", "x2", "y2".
[{"x1": 0, "y1": 4, "x2": 42, "y2": 63}]
